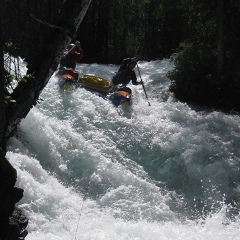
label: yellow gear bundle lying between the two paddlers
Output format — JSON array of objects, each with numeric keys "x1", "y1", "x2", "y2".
[{"x1": 78, "y1": 74, "x2": 110, "y2": 93}]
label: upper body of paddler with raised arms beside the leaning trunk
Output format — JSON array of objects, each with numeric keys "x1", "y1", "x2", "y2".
[{"x1": 60, "y1": 41, "x2": 84, "y2": 69}]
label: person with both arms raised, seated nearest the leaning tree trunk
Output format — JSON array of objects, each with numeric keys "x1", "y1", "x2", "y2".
[{"x1": 59, "y1": 41, "x2": 84, "y2": 79}]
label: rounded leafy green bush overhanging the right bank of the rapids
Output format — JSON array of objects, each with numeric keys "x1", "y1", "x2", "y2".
[{"x1": 168, "y1": 43, "x2": 217, "y2": 103}]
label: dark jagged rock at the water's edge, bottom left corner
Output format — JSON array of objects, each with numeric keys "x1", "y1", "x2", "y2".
[{"x1": 0, "y1": 155, "x2": 28, "y2": 240}]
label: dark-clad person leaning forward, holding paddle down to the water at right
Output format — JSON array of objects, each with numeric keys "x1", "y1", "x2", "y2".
[{"x1": 110, "y1": 58, "x2": 142, "y2": 92}]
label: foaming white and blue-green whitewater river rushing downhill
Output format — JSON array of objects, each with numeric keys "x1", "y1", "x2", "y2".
[{"x1": 7, "y1": 60, "x2": 240, "y2": 240}]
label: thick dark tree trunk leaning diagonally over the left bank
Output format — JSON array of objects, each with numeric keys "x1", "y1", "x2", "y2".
[{"x1": 1, "y1": 0, "x2": 91, "y2": 146}]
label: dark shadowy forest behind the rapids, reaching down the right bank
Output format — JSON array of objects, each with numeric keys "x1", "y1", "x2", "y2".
[{"x1": 4, "y1": 0, "x2": 240, "y2": 111}]
